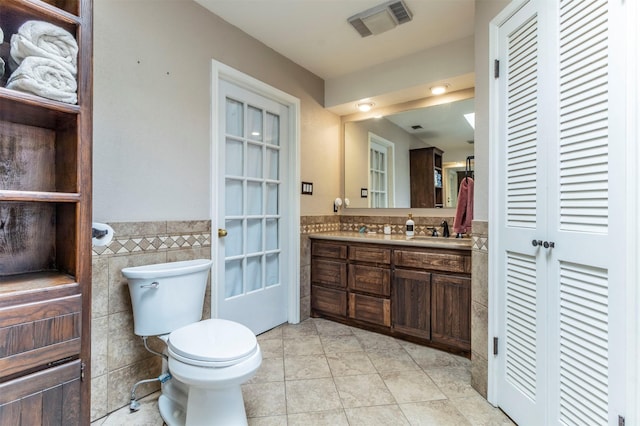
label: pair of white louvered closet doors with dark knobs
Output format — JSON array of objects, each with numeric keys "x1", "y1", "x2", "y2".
[{"x1": 498, "y1": 0, "x2": 625, "y2": 425}]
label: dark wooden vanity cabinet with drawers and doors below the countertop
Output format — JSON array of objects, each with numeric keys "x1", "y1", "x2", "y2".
[{"x1": 311, "y1": 240, "x2": 471, "y2": 355}]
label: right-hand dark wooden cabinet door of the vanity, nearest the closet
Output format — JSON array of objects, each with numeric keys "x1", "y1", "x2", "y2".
[{"x1": 431, "y1": 274, "x2": 471, "y2": 351}]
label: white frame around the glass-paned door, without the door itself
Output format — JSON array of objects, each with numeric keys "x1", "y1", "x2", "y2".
[{"x1": 209, "y1": 60, "x2": 300, "y2": 324}]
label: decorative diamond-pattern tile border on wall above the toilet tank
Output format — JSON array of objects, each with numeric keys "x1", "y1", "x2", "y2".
[{"x1": 93, "y1": 221, "x2": 211, "y2": 256}]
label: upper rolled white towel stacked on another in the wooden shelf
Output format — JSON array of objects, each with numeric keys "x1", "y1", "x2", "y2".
[{"x1": 11, "y1": 21, "x2": 78, "y2": 75}]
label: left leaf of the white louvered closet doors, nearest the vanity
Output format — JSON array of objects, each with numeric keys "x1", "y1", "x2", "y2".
[{"x1": 496, "y1": 3, "x2": 548, "y2": 425}]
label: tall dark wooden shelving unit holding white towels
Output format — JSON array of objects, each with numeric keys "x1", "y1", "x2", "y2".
[{"x1": 0, "y1": 0, "x2": 93, "y2": 425}]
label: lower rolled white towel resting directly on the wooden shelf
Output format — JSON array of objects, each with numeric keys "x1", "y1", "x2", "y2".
[{"x1": 7, "y1": 56, "x2": 78, "y2": 104}]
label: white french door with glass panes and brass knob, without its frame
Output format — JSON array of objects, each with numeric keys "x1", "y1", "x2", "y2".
[{"x1": 219, "y1": 80, "x2": 291, "y2": 334}]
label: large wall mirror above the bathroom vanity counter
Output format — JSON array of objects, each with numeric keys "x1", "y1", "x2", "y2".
[{"x1": 344, "y1": 90, "x2": 474, "y2": 208}]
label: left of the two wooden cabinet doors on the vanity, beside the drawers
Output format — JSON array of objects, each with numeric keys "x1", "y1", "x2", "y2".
[{"x1": 391, "y1": 269, "x2": 431, "y2": 339}]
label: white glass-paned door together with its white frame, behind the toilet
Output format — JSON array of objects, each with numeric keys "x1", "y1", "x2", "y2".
[{"x1": 211, "y1": 61, "x2": 300, "y2": 334}]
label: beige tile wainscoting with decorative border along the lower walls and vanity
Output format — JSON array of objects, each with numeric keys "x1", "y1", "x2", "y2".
[{"x1": 91, "y1": 215, "x2": 487, "y2": 421}]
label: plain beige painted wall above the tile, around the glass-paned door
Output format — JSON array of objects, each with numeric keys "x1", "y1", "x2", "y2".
[{"x1": 93, "y1": 0, "x2": 341, "y2": 222}]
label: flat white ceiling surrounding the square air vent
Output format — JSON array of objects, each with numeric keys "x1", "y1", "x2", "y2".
[{"x1": 195, "y1": 0, "x2": 475, "y2": 80}]
